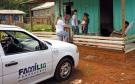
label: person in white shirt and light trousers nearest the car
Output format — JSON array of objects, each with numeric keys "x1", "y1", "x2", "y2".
[{"x1": 55, "y1": 15, "x2": 69, "y2": 42}]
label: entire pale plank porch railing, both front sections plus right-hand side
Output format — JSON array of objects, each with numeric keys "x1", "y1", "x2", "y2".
[{"x1": 33, "y1": 32, "x2": 135, "y2": 53}]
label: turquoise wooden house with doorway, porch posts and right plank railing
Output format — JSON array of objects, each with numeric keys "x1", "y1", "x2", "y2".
[{"x1": 26, "y1": 0, "x2": 135, "y2": 55}]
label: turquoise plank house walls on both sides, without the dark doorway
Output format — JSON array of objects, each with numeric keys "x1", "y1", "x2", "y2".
[{"x1": 55, "y1": 0, "x2": 135, "y2": 35}]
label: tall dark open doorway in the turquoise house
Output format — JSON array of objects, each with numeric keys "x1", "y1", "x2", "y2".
[{"x1": 100, "y1": 0, "x2": 113, "y2": 36}]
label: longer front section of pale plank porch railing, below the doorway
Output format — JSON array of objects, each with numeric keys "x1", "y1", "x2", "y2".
[{"x1": 74, "y1": 35, "x2": 125, "y2": 50}]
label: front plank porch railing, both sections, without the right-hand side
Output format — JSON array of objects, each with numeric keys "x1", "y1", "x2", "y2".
[{"x1": 33, "y1": 32, "x2": 125, "y2": 50}]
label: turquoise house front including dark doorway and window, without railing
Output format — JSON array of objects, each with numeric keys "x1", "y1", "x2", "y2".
[{"x1": 55, "y1": 0, "x2": 135, "y2": 36}]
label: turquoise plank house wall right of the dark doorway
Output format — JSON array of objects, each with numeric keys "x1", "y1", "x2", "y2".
[{"x1": 113, "y1": 0, "x2": 135, "y2": 35}]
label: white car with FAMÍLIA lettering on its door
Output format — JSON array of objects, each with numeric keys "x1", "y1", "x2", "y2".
[{"x1": 0, "y1": 25, "x2": 79, "y2": 84}]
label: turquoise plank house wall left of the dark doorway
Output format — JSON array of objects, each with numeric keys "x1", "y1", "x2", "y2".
[{"x1": 55, "y1": 0, "x2": 100, "y2": 34}]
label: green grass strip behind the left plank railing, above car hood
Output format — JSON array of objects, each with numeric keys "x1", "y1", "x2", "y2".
[{"x1": 24, "y1": 24, "x2": 52, "y2": 32}]
